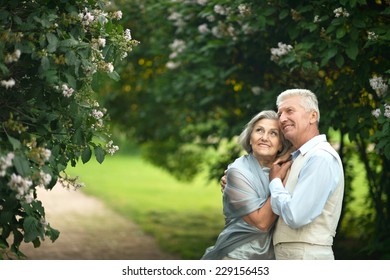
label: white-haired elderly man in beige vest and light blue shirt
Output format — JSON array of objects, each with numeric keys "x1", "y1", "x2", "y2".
[{"x1": 269, "y1": 89, "x2": 344, "y2": 260}]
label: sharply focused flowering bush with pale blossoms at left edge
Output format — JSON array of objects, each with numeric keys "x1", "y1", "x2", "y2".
[{"x1": 0, "y1": 0, "x2": 138, "y2": 258}]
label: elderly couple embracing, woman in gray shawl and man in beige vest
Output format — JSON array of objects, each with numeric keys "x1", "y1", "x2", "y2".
[{"x1": 202, "y1": 89, "x2": 344, "y2": 260}]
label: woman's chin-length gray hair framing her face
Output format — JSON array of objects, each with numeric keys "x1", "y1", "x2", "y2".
[{"x1": 238, "y1": 110, "x2": 291, "y2": 157}]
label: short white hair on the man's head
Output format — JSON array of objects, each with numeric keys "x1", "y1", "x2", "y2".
[{"x1": 276, "y1": 88, "x2": 320, "y2": 123}]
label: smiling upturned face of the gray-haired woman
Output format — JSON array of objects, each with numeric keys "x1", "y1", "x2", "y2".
[{"x1": 250, "y1": 119, "x2": 282, "y2": 167}]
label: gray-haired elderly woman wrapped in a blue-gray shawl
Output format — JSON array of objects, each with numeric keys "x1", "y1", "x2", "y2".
[{"x1": 202, "y1": 110, "x2": 291, "y2": 260}]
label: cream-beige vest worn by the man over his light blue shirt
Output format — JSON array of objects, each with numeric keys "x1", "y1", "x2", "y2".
[{"x1": 273, "y1": 142, "x2": 344, "y2": 246}]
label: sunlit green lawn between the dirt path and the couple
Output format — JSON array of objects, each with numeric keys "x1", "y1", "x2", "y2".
[{"x1": 67, "y1": 153, "x2": 224, "y2": 259}]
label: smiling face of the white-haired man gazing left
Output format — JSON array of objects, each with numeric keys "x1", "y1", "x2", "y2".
[{"x1": 278, "y1": 96, "x2": 311, "y2": 148}]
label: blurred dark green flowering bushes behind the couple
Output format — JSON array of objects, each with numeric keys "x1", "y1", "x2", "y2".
[{"x1": 103, "y1": 0, "x2": 390, "y2": 258}]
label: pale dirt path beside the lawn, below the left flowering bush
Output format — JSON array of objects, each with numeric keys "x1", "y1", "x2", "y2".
[{"x1": 21, "y1": 186, "x2": 175, "y2": 260}]
